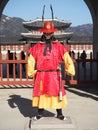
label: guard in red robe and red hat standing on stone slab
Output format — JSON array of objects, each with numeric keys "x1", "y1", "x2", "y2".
[{"x1": 28, "y1": 22, "x2": 75, "y2": 120}]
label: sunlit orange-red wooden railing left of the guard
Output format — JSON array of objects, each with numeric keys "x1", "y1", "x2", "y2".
[{"x1": 0, "y1": 53, "x2": 33, "y2": 85}]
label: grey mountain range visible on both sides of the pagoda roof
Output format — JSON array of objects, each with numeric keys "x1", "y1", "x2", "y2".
[{"x1": 0, "y1": 15, "x2": 93, "y2": 43}]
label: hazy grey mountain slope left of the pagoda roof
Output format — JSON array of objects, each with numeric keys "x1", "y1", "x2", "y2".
[{"x1": 0, "y1": 15, "x2": 27, "y2": 43}]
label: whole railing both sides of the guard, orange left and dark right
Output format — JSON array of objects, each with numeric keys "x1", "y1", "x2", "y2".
[{"x1": 0, "y1": 53, "x2": 98, "y2": 85}]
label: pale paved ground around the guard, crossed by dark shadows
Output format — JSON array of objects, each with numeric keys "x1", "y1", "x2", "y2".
[{"x1": 0, "y1": 85, "x2": 98, "y2": 130}]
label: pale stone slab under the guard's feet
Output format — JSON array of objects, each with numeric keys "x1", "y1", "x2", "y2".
[{"x1": 29, "y1": 116, "x2": 75, "y2": 130}]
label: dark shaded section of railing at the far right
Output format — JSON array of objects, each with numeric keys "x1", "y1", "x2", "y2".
[{"x1": 74, "y1": 53, "x2": 98, "y2": 84}]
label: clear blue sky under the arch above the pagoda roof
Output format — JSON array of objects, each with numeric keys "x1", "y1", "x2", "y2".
[{"x1": 3, "y1": 0, "x2": 92, "y2": 26}]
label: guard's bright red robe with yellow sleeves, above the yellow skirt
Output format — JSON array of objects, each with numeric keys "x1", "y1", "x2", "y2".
[{"x1": 28, "y1": 41, "x2": 75, "y2": 108}]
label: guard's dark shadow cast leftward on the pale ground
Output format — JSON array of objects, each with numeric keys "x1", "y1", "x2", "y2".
[{"x1": 8, "y1": 95, "x2": 54, "y2": 118}]
